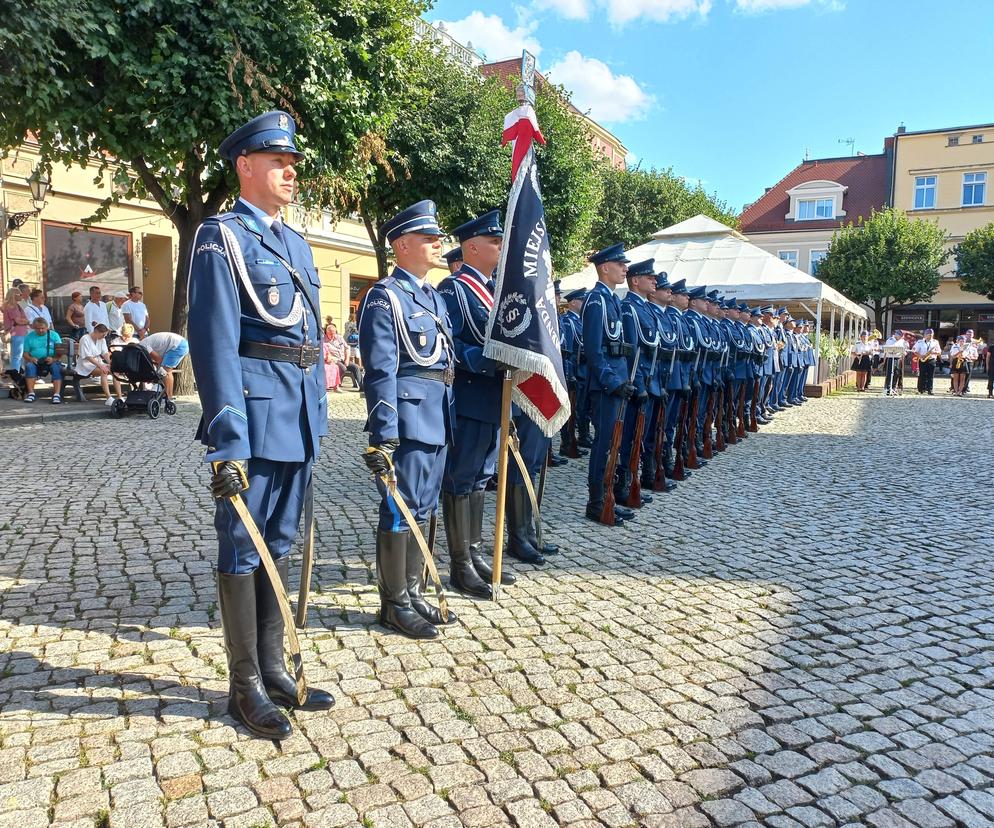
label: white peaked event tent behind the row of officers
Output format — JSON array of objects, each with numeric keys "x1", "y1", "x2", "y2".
[{"x1": 562, "y1": 215, "x2": 868, "y2": 378}]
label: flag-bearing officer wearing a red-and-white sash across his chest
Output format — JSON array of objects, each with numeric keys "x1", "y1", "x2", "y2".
[{"x1": 438, "y1": 210, "x2": 515, "y2": 598}]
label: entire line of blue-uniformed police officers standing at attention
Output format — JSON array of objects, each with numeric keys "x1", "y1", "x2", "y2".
[{"x1": 189, "y1": 112, "x2": 814, "y2": 739}]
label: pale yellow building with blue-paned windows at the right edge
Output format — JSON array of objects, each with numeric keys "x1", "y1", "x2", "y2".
[{"x1": 890, "y1": 124, "x2": 994, "y2": 341}]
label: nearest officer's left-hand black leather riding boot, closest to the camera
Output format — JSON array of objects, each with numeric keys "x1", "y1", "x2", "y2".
[{"x1": 217, "y1": 572, "x2": 293, "y2": 739}]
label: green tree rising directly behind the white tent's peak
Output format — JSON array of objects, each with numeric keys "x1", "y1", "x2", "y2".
[{"x1": 592, "y1": 166, "x2": 739, "y2": 249}]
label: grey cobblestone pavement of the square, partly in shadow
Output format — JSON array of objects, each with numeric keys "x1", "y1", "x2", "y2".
[{"x1": 0, "y1": 386, "x2": 994, "y2": 828}]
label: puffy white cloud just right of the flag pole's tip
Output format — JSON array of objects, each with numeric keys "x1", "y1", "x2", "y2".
[{"x1": 546, "y1": 51, "x2": 655, "y2": 123}]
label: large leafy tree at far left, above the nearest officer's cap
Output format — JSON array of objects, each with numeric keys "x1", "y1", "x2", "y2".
[{"x1": 0, "y1": 0, "x2": 425, "y2": 348}]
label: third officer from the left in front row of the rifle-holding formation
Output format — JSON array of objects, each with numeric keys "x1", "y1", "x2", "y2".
[{"x1": 642, "y1": 272, "x2": 682, "y2": 492}]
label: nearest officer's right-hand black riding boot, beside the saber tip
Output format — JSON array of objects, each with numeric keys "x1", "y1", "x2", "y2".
[{"x1": 255, "y1": 555, "x2": 335, "y2": 710}]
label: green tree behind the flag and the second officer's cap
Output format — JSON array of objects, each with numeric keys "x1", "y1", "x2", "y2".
[{"x1": 326, "y1": 52, "x2": 601, "y2": 279}]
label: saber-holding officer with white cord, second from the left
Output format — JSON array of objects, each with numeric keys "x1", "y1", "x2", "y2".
[{"x1": 359, "y1": 200, "x2": 456, "y2": 638}]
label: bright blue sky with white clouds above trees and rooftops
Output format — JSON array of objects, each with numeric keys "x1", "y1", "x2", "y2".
[{"x1": 427, "y1": 0, "x2": 994, "y2": 211}]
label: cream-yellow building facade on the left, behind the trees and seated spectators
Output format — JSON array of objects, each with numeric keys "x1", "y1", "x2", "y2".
[{"x1": 0, "y1": 143, "x2": 438, "y2": 331}]
